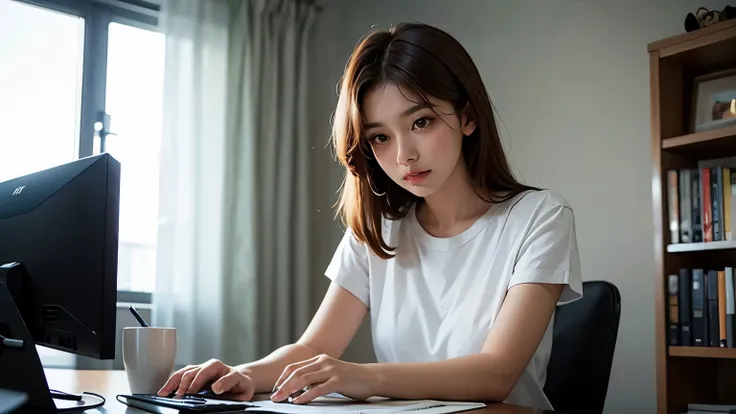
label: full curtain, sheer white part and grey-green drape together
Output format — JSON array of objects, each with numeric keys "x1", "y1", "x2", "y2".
[{"x1": 153, "y1": 0, "x2": 315, "y2": 365}]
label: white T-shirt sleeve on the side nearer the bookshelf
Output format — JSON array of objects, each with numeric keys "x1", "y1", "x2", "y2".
[{"x1": 509, "y1": 197, "x2": 583, "y2": 304}]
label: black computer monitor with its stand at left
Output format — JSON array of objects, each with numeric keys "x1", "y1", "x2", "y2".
[{"x1": 0, "y1": 153, "x2": 120, "y2": 412}]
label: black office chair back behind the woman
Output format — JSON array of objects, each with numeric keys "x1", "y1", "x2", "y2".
[{"x1": 544, "y1": 281, "x2": 621, "y2": 414}]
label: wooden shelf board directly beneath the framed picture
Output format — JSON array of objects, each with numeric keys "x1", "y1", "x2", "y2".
[{"x1": 662, "y1": 125, "x2": 736, "y2": 158}]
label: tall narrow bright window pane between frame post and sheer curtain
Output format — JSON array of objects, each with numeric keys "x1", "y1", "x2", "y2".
[{"x1": 105, "y1": 23, "x2": 165, "y2": 292}]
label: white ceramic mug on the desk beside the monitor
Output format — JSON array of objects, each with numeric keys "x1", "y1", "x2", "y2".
[{"x1": 122, "y1": 327, "x2": 176, "y2": 394}]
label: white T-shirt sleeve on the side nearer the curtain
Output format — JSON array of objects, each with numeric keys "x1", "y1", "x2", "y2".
[{"x1": 325, "y1": 228, "x2": 370, "y2": 307}]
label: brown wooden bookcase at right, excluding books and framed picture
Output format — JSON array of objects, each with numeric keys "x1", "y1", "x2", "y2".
[{"x1": 647, "y1": 20, "x2": 736, "y2": 414}]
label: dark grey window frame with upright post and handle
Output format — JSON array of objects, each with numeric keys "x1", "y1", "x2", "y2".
[{"x1": 14, "y1": 0, "x2": 161, "y2": 304}]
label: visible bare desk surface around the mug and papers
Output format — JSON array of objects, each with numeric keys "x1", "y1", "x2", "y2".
[{"x1": 45, "y1": 369, "x2": 543, "y2": 414}]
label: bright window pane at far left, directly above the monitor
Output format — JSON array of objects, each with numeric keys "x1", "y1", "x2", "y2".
[{"x1": 0, "y1": 1, "x2": 84, "y2": 181}]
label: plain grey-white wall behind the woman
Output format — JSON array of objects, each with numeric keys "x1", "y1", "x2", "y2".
[{"x1": 308, "y1": 0, "x2": 727, "y2": 413}]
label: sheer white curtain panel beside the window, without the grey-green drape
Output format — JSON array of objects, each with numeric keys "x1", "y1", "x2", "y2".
[{"x1": 153, "y1": 0, "x2": 229, "y2": 365}]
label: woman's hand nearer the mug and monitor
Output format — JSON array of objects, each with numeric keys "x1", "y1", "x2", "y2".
[{"x1": 158, "y1": 359, "x2": 255, "y2": 401}]
